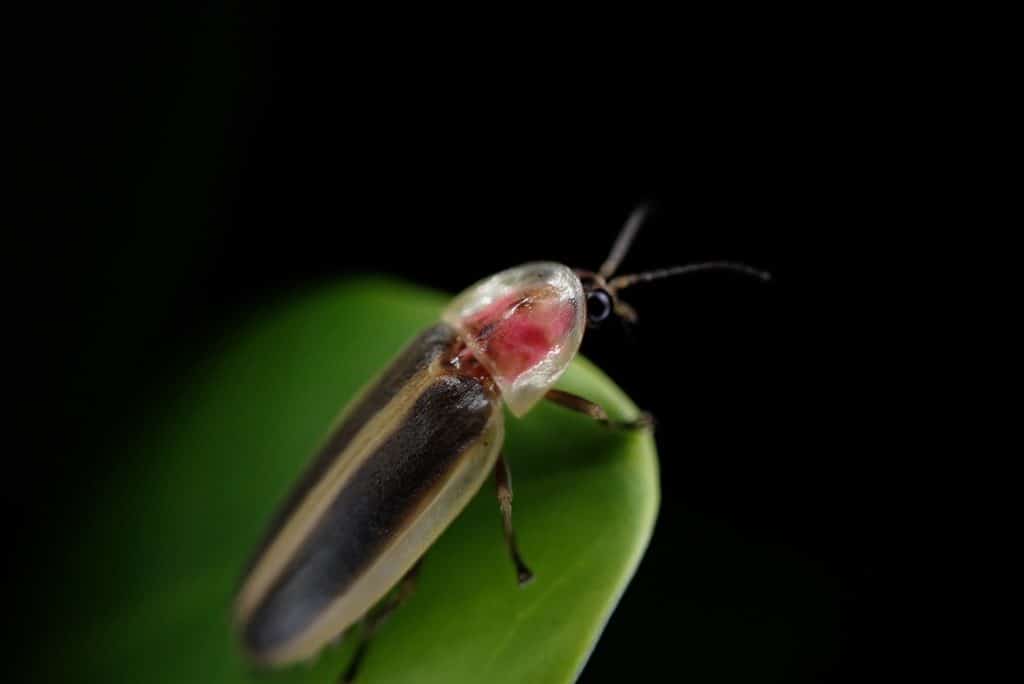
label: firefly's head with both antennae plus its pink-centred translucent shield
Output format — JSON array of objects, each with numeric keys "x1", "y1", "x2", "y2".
[{"x1": 441, "y1": 207, "x2": 768, "y2": 416}]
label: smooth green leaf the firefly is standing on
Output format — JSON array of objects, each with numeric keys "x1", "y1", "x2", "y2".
[{"x1": 44, "y1": 280, "x2": 658, "y2": 684}]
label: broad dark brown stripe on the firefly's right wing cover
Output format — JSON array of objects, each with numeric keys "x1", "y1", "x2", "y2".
[{"x1": 245, "y1": 375, "x2": 493, "y2": 653}]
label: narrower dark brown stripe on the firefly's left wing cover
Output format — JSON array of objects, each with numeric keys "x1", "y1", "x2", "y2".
[{"x1": 244, "y1": 323, "x2": 456, "y2": 576}]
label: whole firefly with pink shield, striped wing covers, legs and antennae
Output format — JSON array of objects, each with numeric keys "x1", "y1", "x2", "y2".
[{"x1": 236, "y1": 208, "x2": 770, "y2": 681}]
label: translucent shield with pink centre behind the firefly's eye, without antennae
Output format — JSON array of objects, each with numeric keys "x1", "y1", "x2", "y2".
[{"x1": 442, "y1": 261, "x2": 587, "y2": 416}]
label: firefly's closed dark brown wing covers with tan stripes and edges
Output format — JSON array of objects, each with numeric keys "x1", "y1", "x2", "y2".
[{"x1": 236, "y1": 324, "x2": 504, "y2": 664}]
